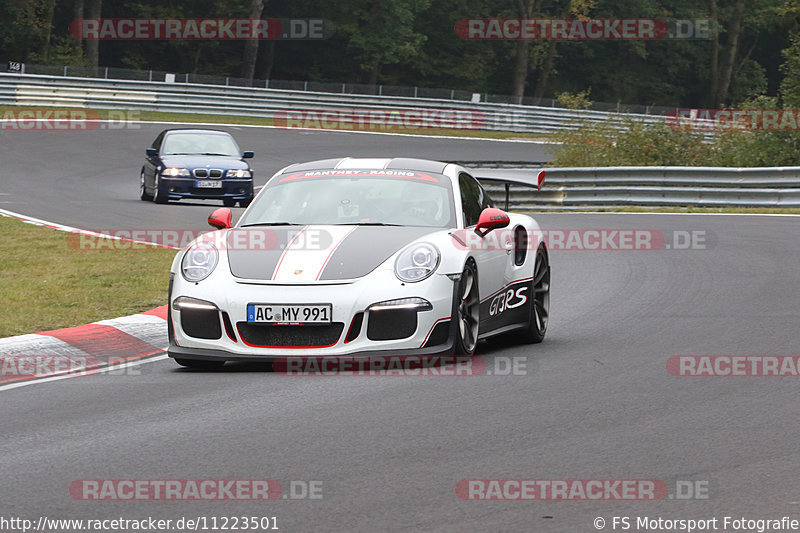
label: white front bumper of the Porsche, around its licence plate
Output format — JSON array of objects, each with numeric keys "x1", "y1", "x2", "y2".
[{"x1": 168, "y1": 269, "x2": 457, "y2": 362}]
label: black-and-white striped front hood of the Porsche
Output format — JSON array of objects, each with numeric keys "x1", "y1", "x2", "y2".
[{"x1": 226, "y1": 225, "x2": 441, "y2": 283}]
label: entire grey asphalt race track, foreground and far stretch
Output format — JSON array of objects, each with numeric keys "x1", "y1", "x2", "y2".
[{"x1": 0, "y1": 126, "x2": 800, "y2": 532}]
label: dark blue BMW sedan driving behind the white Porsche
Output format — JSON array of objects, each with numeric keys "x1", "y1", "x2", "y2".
[{"x1": 139, "y1": 129, "x2": 253, "y2": 207}]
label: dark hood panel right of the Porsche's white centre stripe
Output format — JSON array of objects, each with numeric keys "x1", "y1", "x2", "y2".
[{"x1": 319, "y1": 226, "x2": 440, "y2": 281}]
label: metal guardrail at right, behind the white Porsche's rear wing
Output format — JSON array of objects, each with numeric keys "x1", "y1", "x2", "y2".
[{"x1": 475, "y1": 167, "x2": 800, "y2": 209}]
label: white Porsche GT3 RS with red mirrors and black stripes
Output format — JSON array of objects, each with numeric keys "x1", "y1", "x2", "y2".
[{"x1": 168, "y1": 158, "x2": 550, "y2": 367}]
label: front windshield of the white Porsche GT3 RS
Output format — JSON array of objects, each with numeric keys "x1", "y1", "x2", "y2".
[{"x1": 240, "y1": 170, "x2": 456, "y2": 228}]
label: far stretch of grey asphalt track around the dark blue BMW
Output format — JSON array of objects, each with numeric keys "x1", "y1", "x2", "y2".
[{"x1": 0, "y1": 123, "x2": 550, "y2": 238}]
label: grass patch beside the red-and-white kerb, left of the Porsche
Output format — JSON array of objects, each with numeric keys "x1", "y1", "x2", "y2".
[{"x1": 0, "y1": 217, "x2": 175, "y2": 338}]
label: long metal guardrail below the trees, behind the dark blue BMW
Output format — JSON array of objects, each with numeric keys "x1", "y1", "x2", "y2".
[{"x1": 0, "y1": 73, "x2": 666, "y2": 134}]
